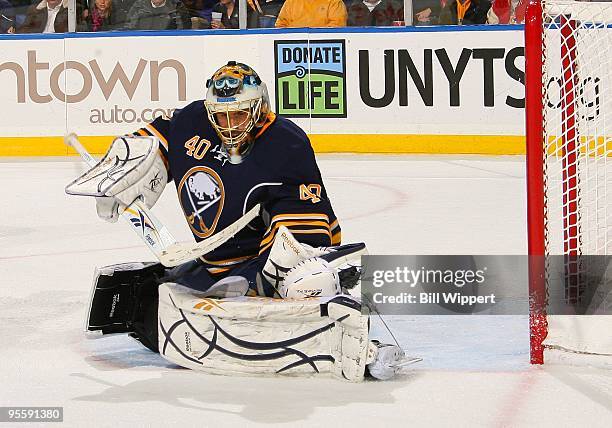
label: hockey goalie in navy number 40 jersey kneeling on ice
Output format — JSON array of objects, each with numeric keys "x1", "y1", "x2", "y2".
[{"x1": 66, "y1": 62, "x2": 404, "y2": 381}]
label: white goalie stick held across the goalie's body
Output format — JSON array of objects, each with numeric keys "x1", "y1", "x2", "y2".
[{"x1": 64, "y1": 133, "x2": 260, "y2": 267}]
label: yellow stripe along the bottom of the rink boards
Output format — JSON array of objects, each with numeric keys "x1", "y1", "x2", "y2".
[{"x1": 0, "y1": 134, "x2": 525, "y2": 156}]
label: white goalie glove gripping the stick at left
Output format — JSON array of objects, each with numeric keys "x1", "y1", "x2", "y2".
[{"x1": 66, "y1": 136, "x2": 168, "y2": 222}]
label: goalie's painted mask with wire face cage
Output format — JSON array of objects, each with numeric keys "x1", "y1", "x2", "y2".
[{"x1": 204, "y1": 61, "x2": 270, "y2": 164}]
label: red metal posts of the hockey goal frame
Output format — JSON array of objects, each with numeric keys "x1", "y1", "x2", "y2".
[{"x1": 525, "y1": 0, "x2": 600, "y2": 364}]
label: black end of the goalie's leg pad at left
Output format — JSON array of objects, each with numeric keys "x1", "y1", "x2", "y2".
[{"x1": 85, "y1": 263, "x2": 165, "y2": 334}]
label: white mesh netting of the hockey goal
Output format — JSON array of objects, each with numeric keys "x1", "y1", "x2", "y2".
[{"x1": 542, "y1": 1, "x2": 612, "y2": 360}]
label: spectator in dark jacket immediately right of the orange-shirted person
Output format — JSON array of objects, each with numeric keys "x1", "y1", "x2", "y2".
[{"x1": 348, "y1": 0, "x2": 404, "y2": 27}]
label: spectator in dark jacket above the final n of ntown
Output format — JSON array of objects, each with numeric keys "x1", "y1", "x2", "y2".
[{"x1": 125, "y1": 0, "x2": 184, "y2": 30}]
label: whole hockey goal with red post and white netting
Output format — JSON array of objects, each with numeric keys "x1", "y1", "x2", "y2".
[{"x1": 525, "y1": 0, "x2": 612, "y2": 364}]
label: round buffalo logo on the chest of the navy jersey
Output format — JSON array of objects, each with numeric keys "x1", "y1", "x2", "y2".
[{"x1": 178, "y1": 166, "x2": 225, "y2": 238}]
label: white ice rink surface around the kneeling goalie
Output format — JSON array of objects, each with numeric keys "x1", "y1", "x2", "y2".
[{"x1": 0, "y1": 155, "x2": 612, "y2": 427}]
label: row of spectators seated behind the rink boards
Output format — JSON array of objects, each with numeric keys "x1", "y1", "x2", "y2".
[{"x1": 0, "y1": 0, "x2": 527, "y2": 33}]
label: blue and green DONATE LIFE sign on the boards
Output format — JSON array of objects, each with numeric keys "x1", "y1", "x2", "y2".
[{"x1": 274, "y1": 40, "x2": 346, "y2": 118}]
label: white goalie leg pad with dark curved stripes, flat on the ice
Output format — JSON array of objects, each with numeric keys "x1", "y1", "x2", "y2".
[{"x1": 158, "y1": 283, "x2": 369, "y2": 381}]
